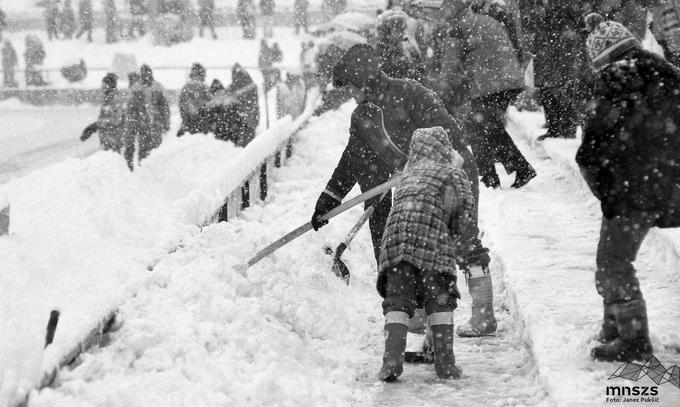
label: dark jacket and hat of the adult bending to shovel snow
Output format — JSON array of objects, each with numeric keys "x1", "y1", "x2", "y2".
[{"x1": 326, "y1": 45, "x2": 473, "y2": 200}]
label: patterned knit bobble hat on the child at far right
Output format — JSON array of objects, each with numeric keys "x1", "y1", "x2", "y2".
[{"x1": 586, "y1": 13, "x2": 642, "y2": 69}]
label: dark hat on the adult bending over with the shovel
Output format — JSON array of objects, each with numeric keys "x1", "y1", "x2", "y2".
[{"x1": 333, "y1": 44, "x2": 380, "y2": 88}]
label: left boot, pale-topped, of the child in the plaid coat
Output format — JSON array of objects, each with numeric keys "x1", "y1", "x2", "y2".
[{"x1": 378, "y1": 311, "x2": 408, "y2": 382}]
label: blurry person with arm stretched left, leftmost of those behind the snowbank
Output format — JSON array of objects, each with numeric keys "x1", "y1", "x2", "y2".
[{"x1": 80, "y1": 73, "x2": 125, "y2": 153}]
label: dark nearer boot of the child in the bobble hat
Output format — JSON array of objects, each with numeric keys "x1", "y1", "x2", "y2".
[{"x1": 591, "y1": 300, "x2": 653, "y2": 362}]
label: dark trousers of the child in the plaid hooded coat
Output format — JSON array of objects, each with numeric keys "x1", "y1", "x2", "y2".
[{"x1": 382, "y1": 262, "x2": 460, "y2": 318}]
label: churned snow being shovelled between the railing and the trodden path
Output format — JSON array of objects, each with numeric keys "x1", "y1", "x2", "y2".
[{"x1": 22, "y1": 104, "x2": 552, "y2": 406}]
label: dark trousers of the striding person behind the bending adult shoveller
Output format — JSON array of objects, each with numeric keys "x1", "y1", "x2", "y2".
[{"x1": 470, "y1": 89, "x2": 531, "y2": 177}]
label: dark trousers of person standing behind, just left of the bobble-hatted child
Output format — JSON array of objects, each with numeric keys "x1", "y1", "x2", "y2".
[{"x1": 539, "y1": 84, "x2": 578, "y2": 138}]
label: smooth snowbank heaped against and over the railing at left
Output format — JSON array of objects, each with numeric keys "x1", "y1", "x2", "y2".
[{"x1": 0, "y1": 87, "x2": 316, "y2": 407}]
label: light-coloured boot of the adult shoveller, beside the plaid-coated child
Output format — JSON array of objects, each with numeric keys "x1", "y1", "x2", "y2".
[{"x1": 456, "y1": 266, "x2": 496, "y2": 338}]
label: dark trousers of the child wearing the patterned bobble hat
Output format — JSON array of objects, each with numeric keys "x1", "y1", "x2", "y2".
[{"x1": 595, "y1": 211, "x2": 658, "y2": 304}]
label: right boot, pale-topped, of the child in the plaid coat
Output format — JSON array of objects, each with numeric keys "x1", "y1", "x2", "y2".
[{"x1": 430, "y1": 312, "x2": 462, "y2": 379}]
